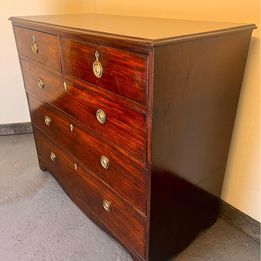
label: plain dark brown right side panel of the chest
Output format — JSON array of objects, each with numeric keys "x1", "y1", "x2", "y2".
[{"x1": 149, "y1": 31, "x2": 254, "y2": 261}]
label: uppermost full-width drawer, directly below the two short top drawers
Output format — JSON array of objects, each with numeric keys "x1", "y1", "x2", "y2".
[{"x1": 21, "y1": 60, "x2": 146, "y2": 162}]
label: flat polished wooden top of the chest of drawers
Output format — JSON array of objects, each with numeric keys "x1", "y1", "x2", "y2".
[{"x1": 11, "y1": 14, "x2": 255, "y2": 45}]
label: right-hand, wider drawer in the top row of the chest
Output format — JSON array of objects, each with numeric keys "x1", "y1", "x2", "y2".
[{"x1": 61, "y1": 38, "x2": 147, "y2": 104}]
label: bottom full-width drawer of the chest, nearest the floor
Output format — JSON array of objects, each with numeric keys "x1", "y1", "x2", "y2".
[{"x1": 34, "y1": 129, "x2": 145, "y2": 256}]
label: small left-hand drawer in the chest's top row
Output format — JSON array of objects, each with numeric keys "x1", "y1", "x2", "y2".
[{"x1": 14, "y1": 26, "x2": 61, "y2": 71}]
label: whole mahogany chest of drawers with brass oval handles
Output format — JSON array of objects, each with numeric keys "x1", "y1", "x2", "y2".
[{"x1": 11, "y1": 14, "x2": 255, "y2": 260}]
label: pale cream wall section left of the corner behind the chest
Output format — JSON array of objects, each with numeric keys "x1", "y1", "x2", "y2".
[{"x1": 0, "y1": 0, "x2": 94, "y2": 124}]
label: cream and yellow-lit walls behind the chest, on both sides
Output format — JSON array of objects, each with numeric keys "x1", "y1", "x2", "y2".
[{"x1": 0, "y1": 0, "x2": 261, "y2": 221}]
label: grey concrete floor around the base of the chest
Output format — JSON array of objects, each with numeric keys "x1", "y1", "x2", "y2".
[{"x1": 0, "y1": 134, "x2": 260, "y2": 261}]
